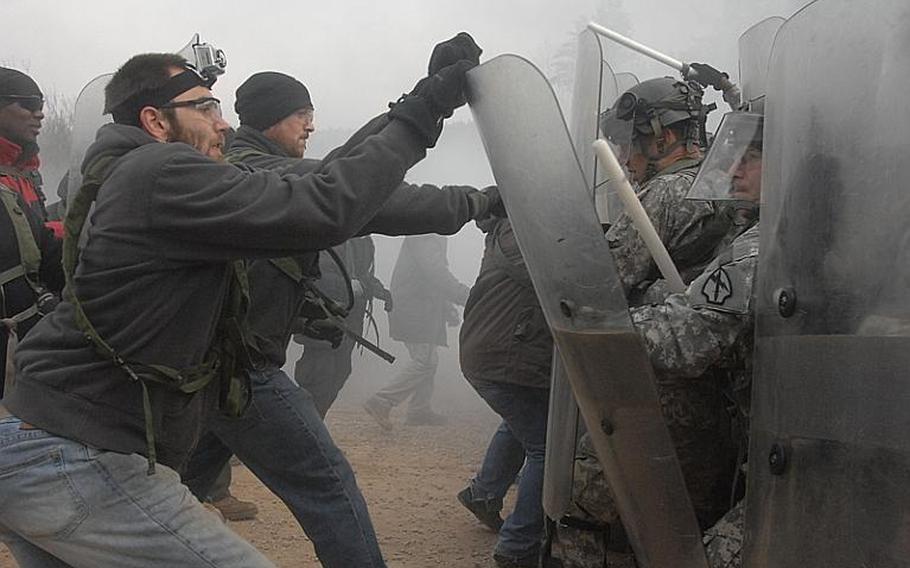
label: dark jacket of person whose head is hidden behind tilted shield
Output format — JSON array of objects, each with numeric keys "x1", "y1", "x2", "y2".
[{"x1": 459, "y1": 219, "x2": 553, "y2": 388}]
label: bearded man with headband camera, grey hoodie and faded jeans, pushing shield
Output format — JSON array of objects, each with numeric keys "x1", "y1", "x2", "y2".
[{"x1": 0, "y1": 33, "x2": 479, "y2": 568}]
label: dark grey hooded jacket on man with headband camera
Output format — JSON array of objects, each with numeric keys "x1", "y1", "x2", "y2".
[{"x1": 4, "y1": 119, "x2": 425, "y2": 468}]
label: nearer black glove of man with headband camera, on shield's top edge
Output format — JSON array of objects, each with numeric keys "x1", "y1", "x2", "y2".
[{"x1": 389, "y1": 59, "x2": 477, "y2": 148}]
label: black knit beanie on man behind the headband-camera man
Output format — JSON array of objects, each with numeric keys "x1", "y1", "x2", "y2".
[{"x1": 234, "y1": 71, "x2": 313, "y2": 131}]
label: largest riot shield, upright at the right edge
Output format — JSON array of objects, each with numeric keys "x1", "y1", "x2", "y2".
[{"x1": 745, "y1": 0, "x2": 910, "y2": 568}]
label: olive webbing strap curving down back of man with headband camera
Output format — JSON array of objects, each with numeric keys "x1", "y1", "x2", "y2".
[{"x1": 63, "y1": 155, "x2": 231, "y2": 475}]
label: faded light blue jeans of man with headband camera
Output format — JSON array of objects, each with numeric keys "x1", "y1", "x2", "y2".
[{"x1": 0, "y1": 417, "x2": 274, "y2": 568}]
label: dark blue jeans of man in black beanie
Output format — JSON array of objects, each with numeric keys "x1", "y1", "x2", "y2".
[{"x1": 184, "y1": 369, "x2": 385, "y2": 568}]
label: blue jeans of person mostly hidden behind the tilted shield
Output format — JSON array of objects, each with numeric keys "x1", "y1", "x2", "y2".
[{"x1": 471, "y1": 381, "x2": 550, "y2": 558}]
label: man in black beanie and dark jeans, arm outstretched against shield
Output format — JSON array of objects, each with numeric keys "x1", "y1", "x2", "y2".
[{"x1": 183, "y1": 54, "x2": 497, "y2": 568}]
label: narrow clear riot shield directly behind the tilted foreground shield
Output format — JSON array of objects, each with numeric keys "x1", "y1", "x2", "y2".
[{"x1": 543, "y1": 30, "x2": 619, "y2": 519}]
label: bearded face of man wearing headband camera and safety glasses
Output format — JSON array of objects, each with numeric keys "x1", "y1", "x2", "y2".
[{"x1": 164, "y1": 87, "x2": 230, "y2": 160}]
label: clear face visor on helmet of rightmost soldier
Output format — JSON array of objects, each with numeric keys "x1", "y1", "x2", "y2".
[{"x1": 687, "y1": 112, "x2": 763, "y2": 201}]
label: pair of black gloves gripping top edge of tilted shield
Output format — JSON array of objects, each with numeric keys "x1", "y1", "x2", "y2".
[{"x1": 389, "y1": 32, "x2": 483, "y2": 148}]
